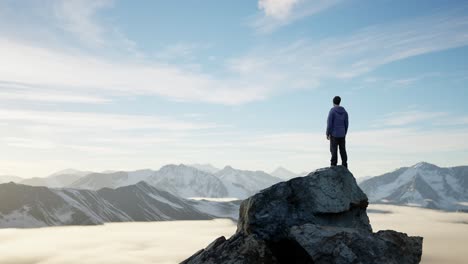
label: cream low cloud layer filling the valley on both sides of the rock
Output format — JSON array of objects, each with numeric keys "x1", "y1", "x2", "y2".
[{"x1": 0, "y1": 205, "x2": 468, "y2": 264}]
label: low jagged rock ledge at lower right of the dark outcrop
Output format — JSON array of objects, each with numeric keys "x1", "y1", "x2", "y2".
[{"x1": 287, "y1": 224, "x2": 422, "y2": 264}]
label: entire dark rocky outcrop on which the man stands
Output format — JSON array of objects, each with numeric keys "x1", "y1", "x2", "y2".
[{"x1": 182, "y1": 166, "x2": 423, "y2": 264}]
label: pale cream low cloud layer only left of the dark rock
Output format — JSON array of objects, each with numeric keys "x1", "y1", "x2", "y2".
[{"x1": 0, "y1": 220, "x2": 236, "y2": 264}]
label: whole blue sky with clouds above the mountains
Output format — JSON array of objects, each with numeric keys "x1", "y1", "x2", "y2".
[{"x1": 0, "y1": 0, "x2": 468, "y2": 177}]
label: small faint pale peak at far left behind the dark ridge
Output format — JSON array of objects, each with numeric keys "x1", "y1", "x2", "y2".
[{"x1": 18, "y1": 169, "x2": 91, "y2": 188}]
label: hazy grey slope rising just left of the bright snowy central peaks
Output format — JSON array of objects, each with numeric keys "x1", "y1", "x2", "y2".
[{"x1": 66, "y1": 169, "x2": 155, "y2": 190}]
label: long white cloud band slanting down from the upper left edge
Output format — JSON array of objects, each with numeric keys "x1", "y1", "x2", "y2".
[{"x1": 0, "y1": 40, "x2": 264, "y2": 104}]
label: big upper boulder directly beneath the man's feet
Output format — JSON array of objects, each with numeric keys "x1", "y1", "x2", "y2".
[{"x1": 237, "y1": 167, "x2": 372, "y2": 239}]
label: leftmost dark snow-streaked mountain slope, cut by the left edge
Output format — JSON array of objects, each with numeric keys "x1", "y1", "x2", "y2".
[{"x1": 0, "y1": 183, "x2": 129, "y2": 227}]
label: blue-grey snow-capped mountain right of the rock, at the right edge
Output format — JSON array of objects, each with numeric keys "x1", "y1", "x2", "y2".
[{"x1": 360, "y1": 162, "x2": 468, "y2": 210}]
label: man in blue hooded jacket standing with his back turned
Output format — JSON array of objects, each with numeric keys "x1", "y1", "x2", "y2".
[{"x1": 327, "y1": 96, "x2": 349, "y2": 167}]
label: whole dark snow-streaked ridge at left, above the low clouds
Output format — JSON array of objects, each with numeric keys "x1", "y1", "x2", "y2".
[{"x1": 0, "y1": 182, "x2": 213, "y2": 227}]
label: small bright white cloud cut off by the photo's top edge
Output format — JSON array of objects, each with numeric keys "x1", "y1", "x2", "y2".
[{"x1": 251, "y1": 0, "x2": 342, "y2": 33}]
